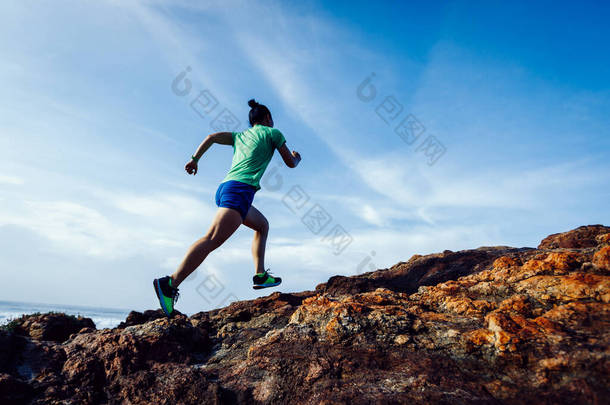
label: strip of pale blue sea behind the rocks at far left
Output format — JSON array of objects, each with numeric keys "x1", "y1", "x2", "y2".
[{"x1": 0, "y1": 301, "x2": 129, "y2": 329}]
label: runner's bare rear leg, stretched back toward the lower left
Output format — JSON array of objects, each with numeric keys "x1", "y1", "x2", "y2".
[{"x1": 172, "y1": 207, "x2": 242, "y2": 288}]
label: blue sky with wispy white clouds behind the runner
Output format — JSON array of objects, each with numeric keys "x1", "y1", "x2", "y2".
[{"x1": 0, "y1": 0, "x2": 610, "y2": 313}]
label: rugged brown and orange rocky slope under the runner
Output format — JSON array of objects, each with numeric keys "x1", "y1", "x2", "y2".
[{"x1": 0, "y1": 225, "x2": 610, "y2": 404}]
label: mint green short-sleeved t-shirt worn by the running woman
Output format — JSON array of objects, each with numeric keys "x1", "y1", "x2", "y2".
[{"x1": 222, "y1": 124, "x2": 286, "y2": 190}]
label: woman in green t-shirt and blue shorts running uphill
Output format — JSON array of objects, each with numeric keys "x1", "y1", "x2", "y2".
[{"x1": 153, "y1": 100, "x2": 301, "y2": 316}]
